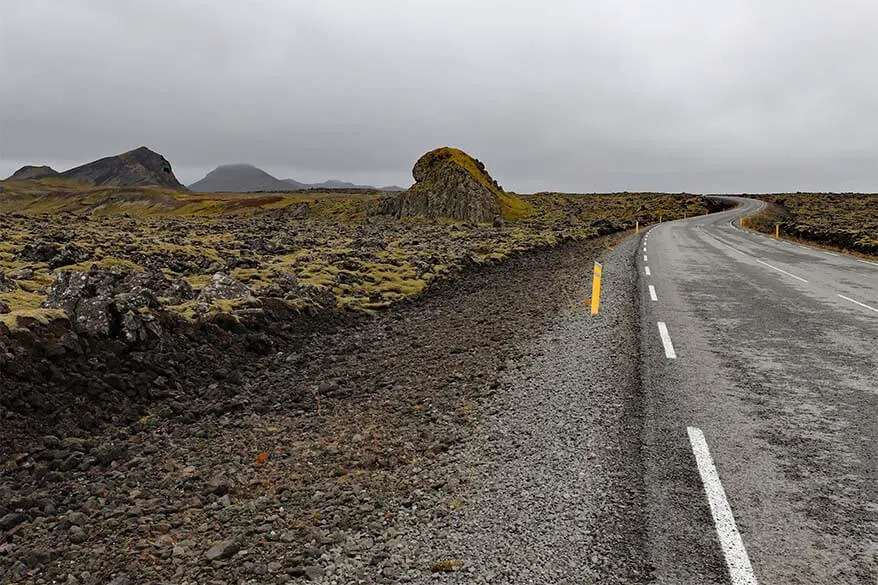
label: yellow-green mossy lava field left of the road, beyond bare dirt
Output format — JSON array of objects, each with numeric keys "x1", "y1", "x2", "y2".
[{"x1": 0, "y1": 179, "x2": 705, "y2": 321}]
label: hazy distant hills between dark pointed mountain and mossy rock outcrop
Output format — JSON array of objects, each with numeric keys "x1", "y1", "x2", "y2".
[{"x1": 189, "y1": 163, "x2": 405, "y2": 193}]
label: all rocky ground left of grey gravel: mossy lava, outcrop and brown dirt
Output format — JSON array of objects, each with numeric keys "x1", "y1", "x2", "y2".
[{"x1": 0, "y1": 145, "x2": 719, "y2": 584}]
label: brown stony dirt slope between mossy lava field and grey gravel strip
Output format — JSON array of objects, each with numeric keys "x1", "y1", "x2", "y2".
[{"x1": 0, "y1": 238, "x2": 611, "y2": 583}]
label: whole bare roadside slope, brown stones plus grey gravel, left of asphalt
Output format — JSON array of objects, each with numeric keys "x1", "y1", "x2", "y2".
[{"x1": 0, "y1": 230, "x2": 642, "y2": 585}]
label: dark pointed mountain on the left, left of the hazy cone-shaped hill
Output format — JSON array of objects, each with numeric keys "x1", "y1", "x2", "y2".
[{"x1": 59, "y1": 146, "x2": 186, "y2": 191}]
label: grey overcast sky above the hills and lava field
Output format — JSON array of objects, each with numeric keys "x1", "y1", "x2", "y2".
[{"x1": 0, "y1": 0, "x2": 878, "y2": 192}]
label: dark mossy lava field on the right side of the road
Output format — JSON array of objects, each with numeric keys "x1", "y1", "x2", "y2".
[{"x1": 748, "y1": 193, "x2": 878, "y2": 257}]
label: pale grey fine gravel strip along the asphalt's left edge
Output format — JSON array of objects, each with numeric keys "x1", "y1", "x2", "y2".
[{"x1": 402, "y1": 232, "x2": 650, "y2": 584}]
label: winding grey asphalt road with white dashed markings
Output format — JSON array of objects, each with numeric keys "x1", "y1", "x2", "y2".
[{"x1": 638, "y1": 199, "x2": 878, "y2": 585}]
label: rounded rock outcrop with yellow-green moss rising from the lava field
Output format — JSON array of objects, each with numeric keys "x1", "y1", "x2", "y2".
[{"x1": 379, "y1": 147, "x2": 526, "y2": 222}]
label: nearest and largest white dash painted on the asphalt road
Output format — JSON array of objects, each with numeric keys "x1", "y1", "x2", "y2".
[{"x1": 686, "y1": 427, "x2": 758, "y2": 585}]
